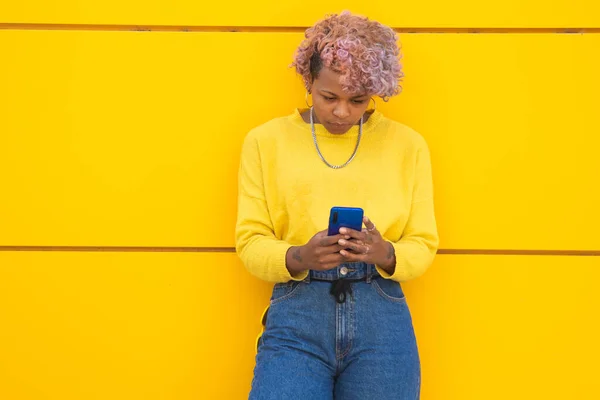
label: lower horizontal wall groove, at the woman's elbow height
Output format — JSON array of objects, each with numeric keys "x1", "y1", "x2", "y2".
[{"x1": 0, "y1": 246, "x2": 600, "y2": 256}]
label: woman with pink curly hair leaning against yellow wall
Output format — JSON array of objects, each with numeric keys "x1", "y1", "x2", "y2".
[{"x1": 236, "y1": 12, "x2": 438, "y2": 400}]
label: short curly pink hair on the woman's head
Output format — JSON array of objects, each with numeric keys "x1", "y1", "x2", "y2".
[{"x1": 291, "y1": 11, "x2": 404, "y2": 101}]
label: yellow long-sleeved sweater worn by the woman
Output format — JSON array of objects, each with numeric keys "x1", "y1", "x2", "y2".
[{"x1": 236, "y1": 109, "x2": 438, "y2": 282}]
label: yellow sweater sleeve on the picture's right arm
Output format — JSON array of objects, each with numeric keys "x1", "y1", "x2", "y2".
[{"x1": 376, "y1": 140, "x2": 439, "y2": 282}]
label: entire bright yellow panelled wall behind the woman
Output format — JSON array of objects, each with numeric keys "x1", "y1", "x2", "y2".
[{"x1": 0, "y1": 0, "x2": 600, "y2": 400}]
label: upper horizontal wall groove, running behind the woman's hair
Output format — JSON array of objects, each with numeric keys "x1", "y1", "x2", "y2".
[{"x1": 0, "y1": 22, "x2": 600, "y2": 34}]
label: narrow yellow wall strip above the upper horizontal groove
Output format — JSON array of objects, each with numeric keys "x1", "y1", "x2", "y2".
[{"x1": 0, "y1": 0, "x2": 600, "y2": 28}]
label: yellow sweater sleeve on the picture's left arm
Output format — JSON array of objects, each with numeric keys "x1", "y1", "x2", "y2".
[{"x1": 235, "y1": 132, "x2": 308, "y2": 282}]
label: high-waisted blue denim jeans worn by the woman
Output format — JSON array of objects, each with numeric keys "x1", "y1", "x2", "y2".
[{"x1": 250, "y1": 263, "x2": 421, "y2": 400}]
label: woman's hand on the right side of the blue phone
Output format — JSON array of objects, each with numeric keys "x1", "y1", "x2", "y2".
[{"x1": 338, "y1": 216, "x2": 396, "y2": 274}]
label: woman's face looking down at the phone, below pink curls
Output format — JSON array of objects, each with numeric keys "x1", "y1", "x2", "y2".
[{"x1": 311, "y1": 67, "x2": 370, "y2": 134}]
